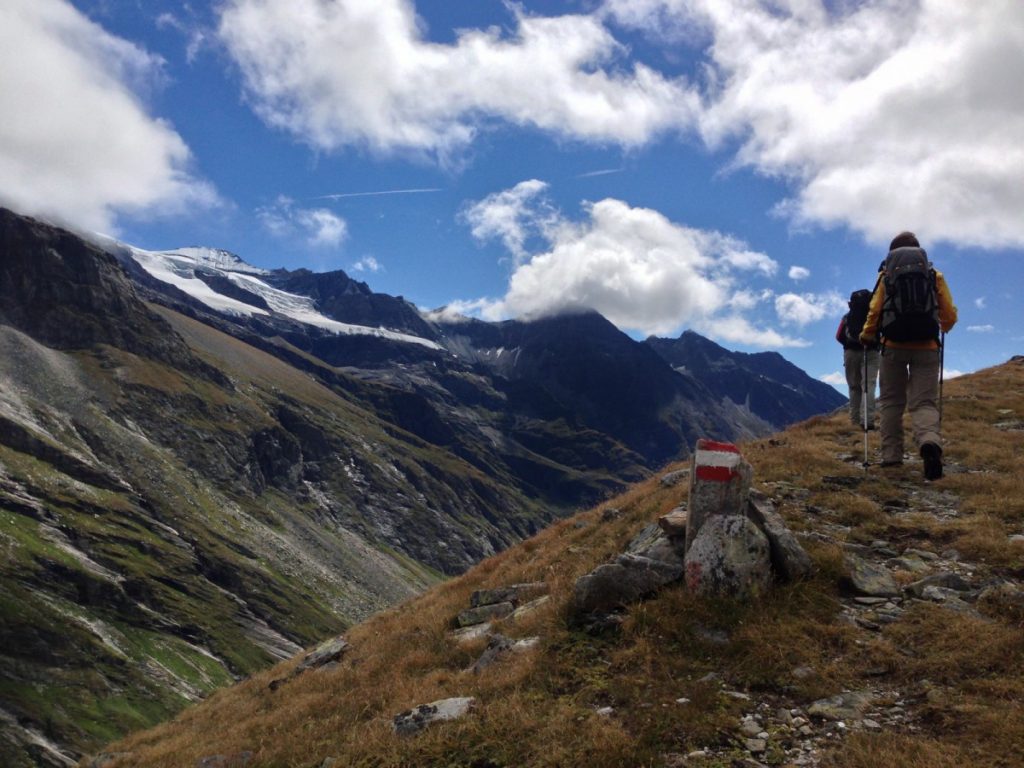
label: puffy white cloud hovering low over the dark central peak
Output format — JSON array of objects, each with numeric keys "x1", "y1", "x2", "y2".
[{"x1": 459, "y1": 181, "x2": 806, "y2": 347}]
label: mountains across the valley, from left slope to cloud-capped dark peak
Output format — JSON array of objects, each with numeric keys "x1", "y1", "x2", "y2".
[{"x1": 0, "y1": 210, "x2": 843, "y2": 765}]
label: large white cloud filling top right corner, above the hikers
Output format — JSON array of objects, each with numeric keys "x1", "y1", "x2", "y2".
[{"x1": 604, "y1": 0, "x2": 1024, "y2": 247}]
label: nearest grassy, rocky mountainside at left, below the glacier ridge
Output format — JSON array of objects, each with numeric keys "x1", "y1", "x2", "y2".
[{"x1": 0, "y1": 211, "x2": 553, "y2": 765}]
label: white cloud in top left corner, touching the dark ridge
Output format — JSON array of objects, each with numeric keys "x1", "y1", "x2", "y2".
[{"x1": 0, "y1": 0, "x2": 217, "y2": 231}]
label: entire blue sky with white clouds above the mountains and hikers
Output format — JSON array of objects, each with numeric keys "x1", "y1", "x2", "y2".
[{"x1": 0, "y1": 0, "x2": 1024, "y2": 382}]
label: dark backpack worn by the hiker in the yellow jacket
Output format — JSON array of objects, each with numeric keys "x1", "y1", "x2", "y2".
[{"x1": 882, "y1": 247, "x2": 939, "y2": 341}]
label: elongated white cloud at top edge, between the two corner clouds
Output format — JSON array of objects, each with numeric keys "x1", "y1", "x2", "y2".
[{"x1": 219, "y1": 0, "x2": 698, "y2": 160}]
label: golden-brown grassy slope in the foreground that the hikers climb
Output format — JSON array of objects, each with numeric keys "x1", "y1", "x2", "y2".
[{"x1": 97, "y1": 361, "x2": 1024, "y2": 768}]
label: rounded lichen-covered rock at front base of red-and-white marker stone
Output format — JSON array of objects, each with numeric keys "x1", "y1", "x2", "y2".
[{"x1": 685, "y1": 515, "x2": 771, "y2": 597}]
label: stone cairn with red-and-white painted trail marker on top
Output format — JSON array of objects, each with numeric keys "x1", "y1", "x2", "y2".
[{"x1": 569, "y1": 439, "x2": 812, "y2": 627}]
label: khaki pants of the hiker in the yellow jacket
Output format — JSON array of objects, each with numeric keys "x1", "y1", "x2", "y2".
[{"x1": 879, "y1": 347, "x2": 942, "y2": 462}]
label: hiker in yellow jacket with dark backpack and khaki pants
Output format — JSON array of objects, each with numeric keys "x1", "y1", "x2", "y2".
[{"x1": 860, "y1": 232, "x2": 956, "y2": 480}]
